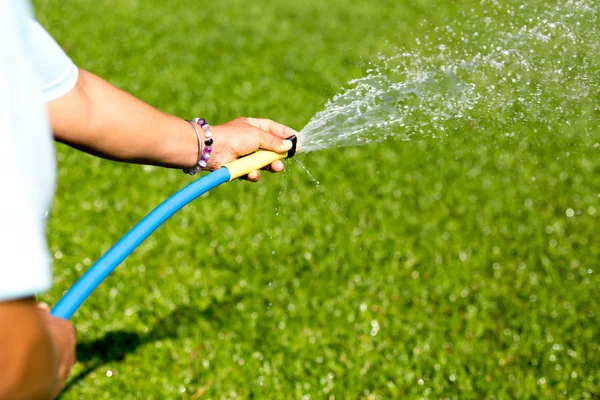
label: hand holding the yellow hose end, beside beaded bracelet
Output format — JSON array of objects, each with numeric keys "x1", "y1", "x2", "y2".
[{"x1": 207, "y1": 117, "x2": 298, "y2": 182}]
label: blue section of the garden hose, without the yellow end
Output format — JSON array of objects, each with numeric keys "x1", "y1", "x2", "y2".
[{"x1": 51, "y1": 167, "x2": 231, "y2": 319}]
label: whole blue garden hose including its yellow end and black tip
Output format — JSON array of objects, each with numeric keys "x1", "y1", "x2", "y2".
[{"x1": 51, "y1": 135, "x2": 297, "y2": 319}]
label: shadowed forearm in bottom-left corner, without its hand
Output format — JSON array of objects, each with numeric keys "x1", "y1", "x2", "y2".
[{"x1": 0, "y1": 299, "x2": 58, "y2": 399}]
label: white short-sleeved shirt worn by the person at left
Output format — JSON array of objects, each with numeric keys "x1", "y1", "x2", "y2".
[{"x1": 0, "y1": 0, "x2": 78, "y2": 301}]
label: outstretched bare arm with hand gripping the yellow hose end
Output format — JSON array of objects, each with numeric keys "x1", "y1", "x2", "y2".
[{"x1": 47, "y1": 69, "x2": 296, "y2": 180}]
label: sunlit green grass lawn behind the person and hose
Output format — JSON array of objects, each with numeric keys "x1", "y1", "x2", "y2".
[{"x1": 35, "y1": 0, "x2": 600, "y2": 399}]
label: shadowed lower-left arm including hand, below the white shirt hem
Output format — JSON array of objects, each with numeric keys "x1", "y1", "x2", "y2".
[{"x1": 0, "y1": 298, "x2": 75, "y2": 400}]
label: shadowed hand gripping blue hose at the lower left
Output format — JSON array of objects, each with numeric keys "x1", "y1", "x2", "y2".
[{"x1": 36, "y1": 303, "x2": 76, "y2": 398}]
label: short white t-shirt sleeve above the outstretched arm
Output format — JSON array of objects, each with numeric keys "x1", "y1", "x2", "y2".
[{"x1": 27, "y1": 18, "x2": 79, "y2": 102}]
